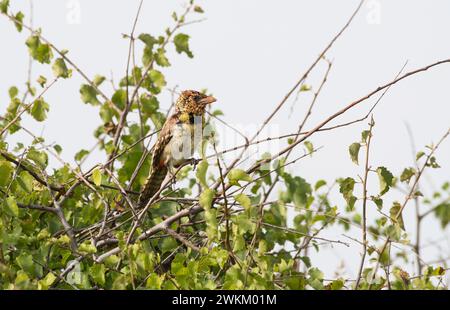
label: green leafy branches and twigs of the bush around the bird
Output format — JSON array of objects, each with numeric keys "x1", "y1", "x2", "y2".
[{"x1": 0, "y1": 0, "x2": 450, "y2": 290}]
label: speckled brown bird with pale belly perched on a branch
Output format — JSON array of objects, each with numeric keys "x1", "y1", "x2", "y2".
[{"x1": 138, "y1": 90, "x2": 216, "y2": 208}]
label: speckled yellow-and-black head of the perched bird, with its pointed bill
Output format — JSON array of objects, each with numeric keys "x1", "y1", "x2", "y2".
[{"x1": 175, "y1": 90, "x2": 216, "y2": 115}]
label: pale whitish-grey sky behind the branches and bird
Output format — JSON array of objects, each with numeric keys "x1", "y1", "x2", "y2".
[{"x1": 0, "y1": 0, "x2": 450, "y2": 284}]
